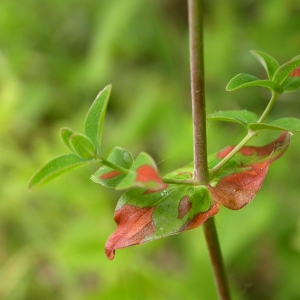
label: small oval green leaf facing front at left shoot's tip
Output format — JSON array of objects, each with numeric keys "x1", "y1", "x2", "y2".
[{"x1": 69, "y1": 133, "x2": 96, "y2": 159}]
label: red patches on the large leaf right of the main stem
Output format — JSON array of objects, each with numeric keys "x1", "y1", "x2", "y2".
[{"x1": 208, "y1": 132, "x2": 289, "y2": 210}]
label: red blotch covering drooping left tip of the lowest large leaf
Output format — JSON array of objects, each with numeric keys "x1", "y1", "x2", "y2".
[{"x1": 105, "y1": 205, "x2": 156, "y2": 259}]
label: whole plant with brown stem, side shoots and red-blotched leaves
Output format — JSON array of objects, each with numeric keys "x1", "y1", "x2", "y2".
[{"x1": 28, "y1": 0, "x2": 300, "y2": 300}]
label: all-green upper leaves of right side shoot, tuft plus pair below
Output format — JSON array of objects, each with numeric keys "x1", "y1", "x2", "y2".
[{"x1": 208, "y1": 50, "x2": 300, "y2": 132}]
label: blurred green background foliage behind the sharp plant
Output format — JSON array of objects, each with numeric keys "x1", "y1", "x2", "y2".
[{"x1": 0, "y1": 0, "x2": 300, "y2": 300}]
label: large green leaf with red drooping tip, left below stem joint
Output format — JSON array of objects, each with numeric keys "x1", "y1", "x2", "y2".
[{"x1": 105, "y1": 180, "x2": 219, "y2": 259}]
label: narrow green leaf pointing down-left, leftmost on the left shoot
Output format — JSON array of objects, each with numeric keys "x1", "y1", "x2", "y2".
[{"x1": 28, "y1": 154, "x2": 93, "y2": 190}]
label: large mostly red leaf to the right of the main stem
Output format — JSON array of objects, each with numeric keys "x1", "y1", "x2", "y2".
[{"x1": 209, "y1": 132, "x2": 290, "y2": 210}]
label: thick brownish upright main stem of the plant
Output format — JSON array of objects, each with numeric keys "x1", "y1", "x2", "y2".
[{"x1": 188, "y1": 0, "x2": 230, "y2": 300}]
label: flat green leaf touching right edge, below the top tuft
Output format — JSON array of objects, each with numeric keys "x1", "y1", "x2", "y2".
[{"x1": 248, "y1": 118, "x2": 300, "y2": 132}]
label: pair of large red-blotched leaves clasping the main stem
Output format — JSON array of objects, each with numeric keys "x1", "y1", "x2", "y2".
[{"x1": 104, "y1": 132, "x2": 290, "y2": 259}]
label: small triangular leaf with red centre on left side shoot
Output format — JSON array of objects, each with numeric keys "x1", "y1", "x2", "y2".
[{"x1": 116, "y1": 152, "x2": 165, "y2": 190}]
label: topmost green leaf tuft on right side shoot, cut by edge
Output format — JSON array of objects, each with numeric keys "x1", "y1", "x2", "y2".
[{"x1": 226, "y1": 50, "x2": 300, "y2": 94}]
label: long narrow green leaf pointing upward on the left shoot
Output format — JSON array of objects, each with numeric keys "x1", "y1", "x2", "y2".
[{"x1": 84, "y1": 85, "x2": 112, "y2": 155}]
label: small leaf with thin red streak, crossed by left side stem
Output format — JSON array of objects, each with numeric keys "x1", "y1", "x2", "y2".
[{"x1": 91, "y1": 147, "x2": 133, "y2": 188}]
